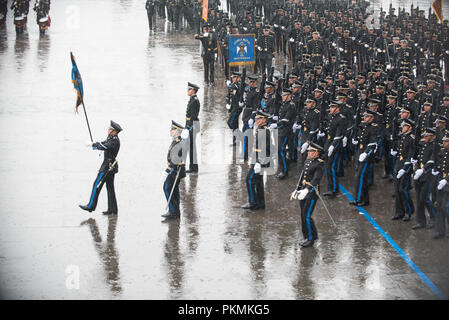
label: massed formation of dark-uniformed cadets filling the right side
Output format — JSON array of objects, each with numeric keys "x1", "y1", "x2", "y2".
[{"x1": 172, "y1": 0, "x2": 449, "y2": 246}]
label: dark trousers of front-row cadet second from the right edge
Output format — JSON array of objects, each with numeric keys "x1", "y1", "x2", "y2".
[{"x1": 415, "y1": 173, "x2": 436, "y2": 225}]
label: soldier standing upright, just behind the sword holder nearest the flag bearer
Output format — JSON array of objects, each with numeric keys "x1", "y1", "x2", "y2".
[{"x1": 185, "y1": 82, "x2": 200, "y2": 173}]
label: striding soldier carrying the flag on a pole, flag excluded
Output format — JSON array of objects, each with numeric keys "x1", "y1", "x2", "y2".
[{"x1": 79, "y1": 120, "x2": 122, "y2": 214}]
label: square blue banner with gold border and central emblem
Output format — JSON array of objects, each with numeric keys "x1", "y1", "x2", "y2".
[{"x1": 229, "y1": 34, "x2": 256, "y2": 67}]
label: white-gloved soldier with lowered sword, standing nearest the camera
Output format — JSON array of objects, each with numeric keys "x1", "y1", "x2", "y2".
[{"x1": 291, "y1": 142, "x2": 324, "y2": 247}]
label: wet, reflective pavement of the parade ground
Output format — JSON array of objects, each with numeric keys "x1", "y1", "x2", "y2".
[{"x1": 0, "y1": 0, "x2": 449, "y2": 300}]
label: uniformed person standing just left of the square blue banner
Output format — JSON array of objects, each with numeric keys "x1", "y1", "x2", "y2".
[{"x1": 195, "y1": 24, "x2": 218, "y2": 86}]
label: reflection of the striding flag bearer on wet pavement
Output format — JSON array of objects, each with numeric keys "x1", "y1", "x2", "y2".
[{"x1": 81, "y1": 215, "x2": 122, "y2": 292}]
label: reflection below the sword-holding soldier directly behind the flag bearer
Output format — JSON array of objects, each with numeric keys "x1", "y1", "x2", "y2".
[{"x1": 164, "y1": 220, "x2": 184, "y2": 295}]
